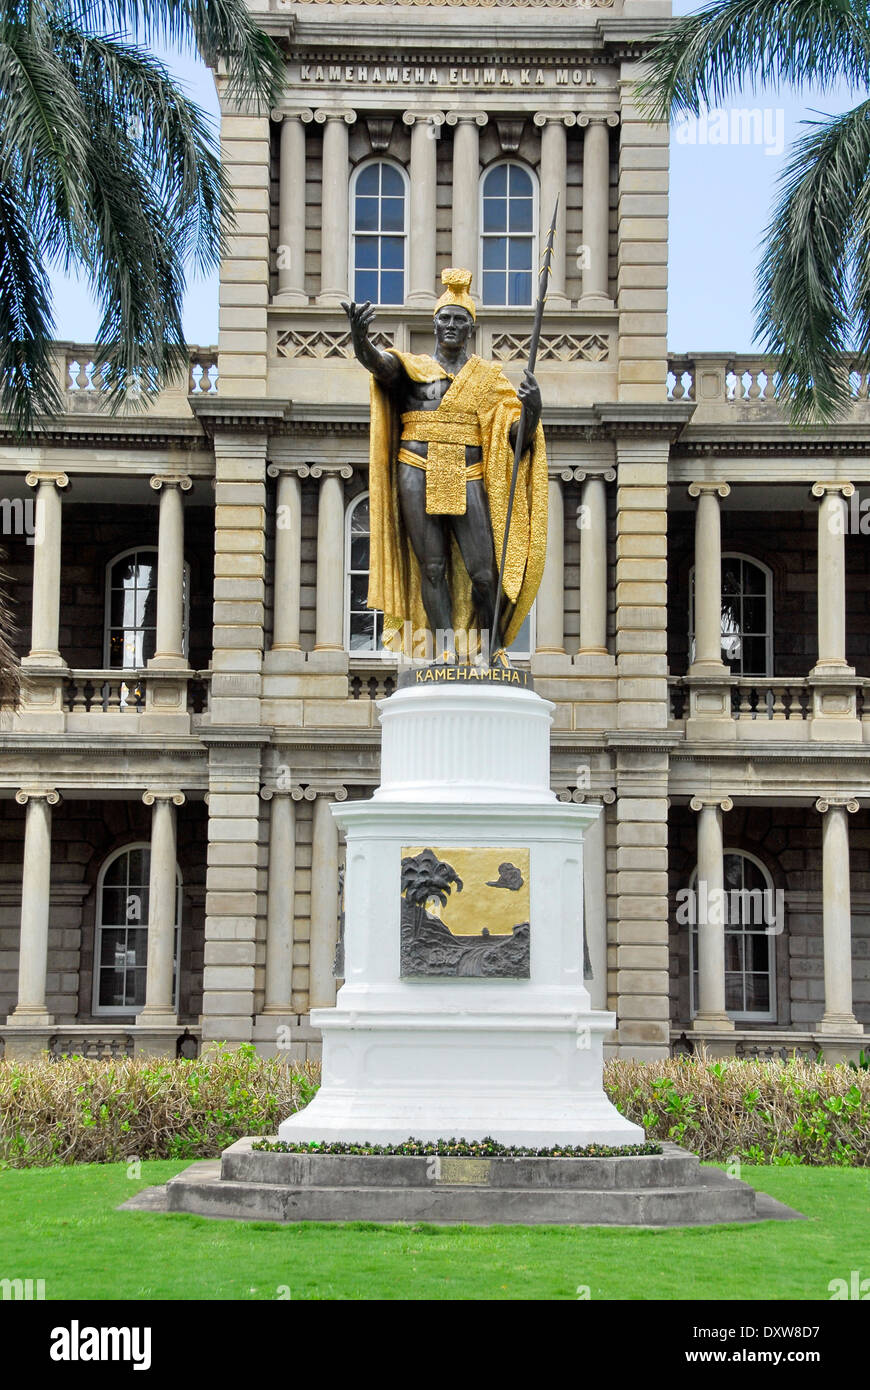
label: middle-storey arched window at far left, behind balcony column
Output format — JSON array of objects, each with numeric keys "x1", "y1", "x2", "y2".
[{"x1": 103, "y1": 546, "x2": 190, "y2": 670}]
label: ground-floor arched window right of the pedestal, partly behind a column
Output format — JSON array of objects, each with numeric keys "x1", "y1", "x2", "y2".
[{"x1": 689, "y1": 849, "x2": 782, "y2": 1023}]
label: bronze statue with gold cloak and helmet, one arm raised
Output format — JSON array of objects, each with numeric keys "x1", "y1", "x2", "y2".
[{"x1": 343, "y1": 270, "x2": 548, "y2": 655}]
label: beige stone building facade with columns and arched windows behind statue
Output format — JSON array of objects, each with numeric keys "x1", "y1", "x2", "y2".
[{"x1": 0, "y1": 0, "x2": 870, "y2": 1058}]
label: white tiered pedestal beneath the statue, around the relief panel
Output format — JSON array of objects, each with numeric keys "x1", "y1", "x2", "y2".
[{"x1": 278, "y1": 684, "x2": 643, "y2": 1147}]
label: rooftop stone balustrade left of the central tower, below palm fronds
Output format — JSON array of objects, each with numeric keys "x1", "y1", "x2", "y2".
[{"x1": 54, "y1": 343, "x2": 218, "y2": 416}]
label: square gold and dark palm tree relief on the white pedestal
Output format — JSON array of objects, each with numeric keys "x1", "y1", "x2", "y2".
[{"x1": 402, "y1": 848, "x2": 530, "y2": 980}]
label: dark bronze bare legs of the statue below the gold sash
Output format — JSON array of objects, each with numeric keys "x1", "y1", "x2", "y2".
[{"x1": 397, "y1": 463, "x2": 499, "y2": 645}]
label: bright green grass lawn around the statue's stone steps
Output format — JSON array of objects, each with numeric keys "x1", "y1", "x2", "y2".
[{"x1": 0, "y1": 1161, "x2": 870, "y2": 1300}]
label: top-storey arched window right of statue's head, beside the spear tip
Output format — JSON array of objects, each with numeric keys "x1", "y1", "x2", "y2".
[{"x1": 479, "y1": 160, "x2": 538, "y2": 306}]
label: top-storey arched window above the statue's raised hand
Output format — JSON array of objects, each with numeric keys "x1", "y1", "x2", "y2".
[{"x1": 350, "y1": 160, "x2": 409, "y2": 304}]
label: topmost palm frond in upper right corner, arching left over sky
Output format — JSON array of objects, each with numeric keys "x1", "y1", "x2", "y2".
[{"x1": 638, "y1": 0, "x2": 870, "y2": 121}]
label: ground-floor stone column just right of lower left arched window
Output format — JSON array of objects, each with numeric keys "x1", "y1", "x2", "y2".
[{"x1": 136, "y1": 791, "x2": 185, "y2": 1027}]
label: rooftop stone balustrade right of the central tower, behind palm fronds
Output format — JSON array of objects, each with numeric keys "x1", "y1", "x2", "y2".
[{"x1": 667, "y1": 353, "x2": 870, "y2": 424}]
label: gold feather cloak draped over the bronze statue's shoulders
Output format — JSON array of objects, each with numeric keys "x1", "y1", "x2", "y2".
[{"x1": 367, "y1": 349, "x2": 548, "y2": 656}]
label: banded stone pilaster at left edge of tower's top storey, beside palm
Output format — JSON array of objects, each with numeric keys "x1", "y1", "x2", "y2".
[{"x1": 218, "y1": 104, "x2": 271, "y2": 398}]
